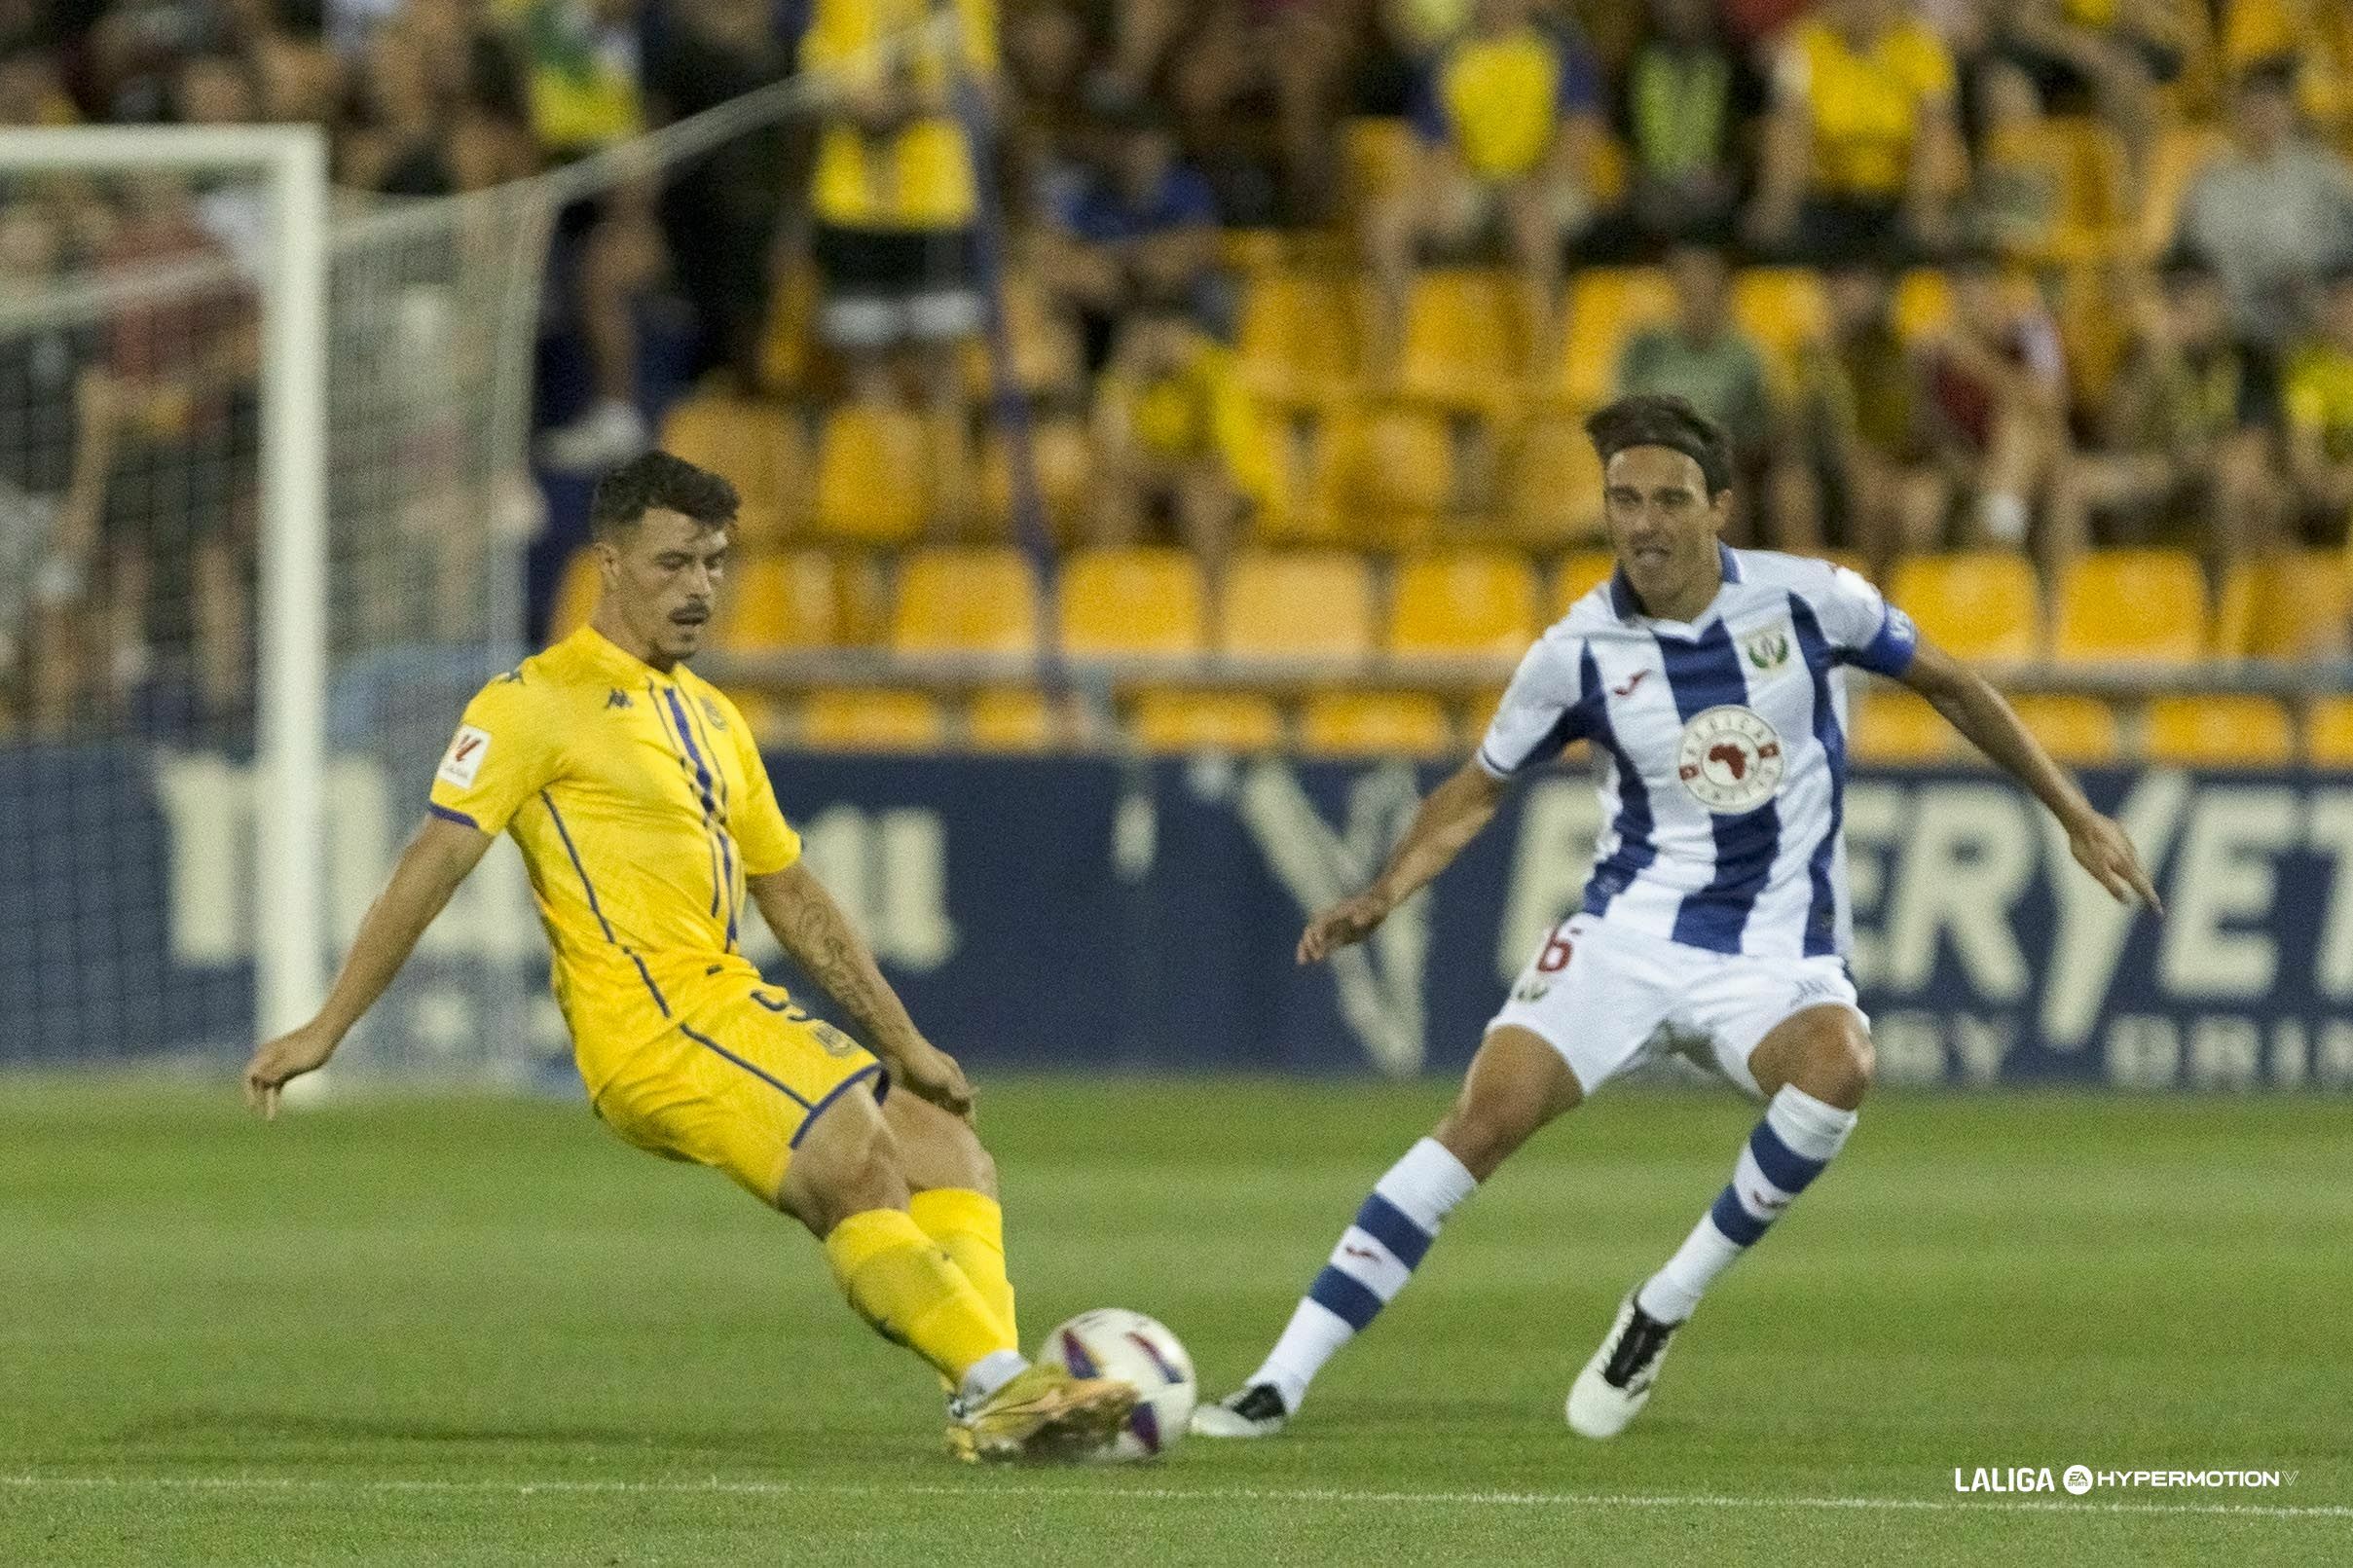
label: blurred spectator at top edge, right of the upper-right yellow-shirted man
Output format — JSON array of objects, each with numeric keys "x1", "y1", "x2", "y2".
[{"x1": 1996, "y1": 0, "x2": 2188, "y2": 171}]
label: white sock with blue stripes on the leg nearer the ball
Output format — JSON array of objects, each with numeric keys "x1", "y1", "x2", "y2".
[{"x1": 1252, "y1": 1138, "x2": 1478, "y2": 1410}]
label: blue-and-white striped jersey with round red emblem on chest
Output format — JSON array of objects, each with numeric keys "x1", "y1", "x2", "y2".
[{"x1": 1478, "y1": 548, "x2": 1918, "y2": 959}]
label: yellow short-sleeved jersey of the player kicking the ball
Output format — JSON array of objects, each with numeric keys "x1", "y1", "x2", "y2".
[{"x1": 419, "y1": 625, "x2": 800, "y2": 1096}]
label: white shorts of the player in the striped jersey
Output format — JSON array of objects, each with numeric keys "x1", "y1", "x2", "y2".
[{"x1": 1488, "y1": 915, "x2": 1871, "y2": 1098}]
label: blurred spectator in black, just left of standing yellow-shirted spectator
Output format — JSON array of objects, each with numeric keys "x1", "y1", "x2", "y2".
[{"x1": 647, "y1": 0, "x2": 807, "y2": 388}]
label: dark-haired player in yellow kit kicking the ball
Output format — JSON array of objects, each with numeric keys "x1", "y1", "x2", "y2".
[{"x1": 244, "y1": 452, "x2": 1134, "y2": 1460}]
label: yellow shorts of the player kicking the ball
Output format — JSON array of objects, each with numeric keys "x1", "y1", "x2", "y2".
[{"x1": 581, "y1": 975, "x2": 890, "y2": 1204}]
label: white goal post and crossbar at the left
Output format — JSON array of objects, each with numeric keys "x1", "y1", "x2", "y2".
[{"x1": 0, "y1": 125, "x2": 329, "y2": 1035}]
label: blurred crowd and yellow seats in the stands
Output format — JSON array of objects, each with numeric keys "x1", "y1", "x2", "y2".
[{"x1": 0, "y1": 0, "x2": 2353, "y2": 761}]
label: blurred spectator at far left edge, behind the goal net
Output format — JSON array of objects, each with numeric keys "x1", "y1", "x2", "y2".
[{"x1": 0, "y1": 202, "x2": 108, "y2": 734}]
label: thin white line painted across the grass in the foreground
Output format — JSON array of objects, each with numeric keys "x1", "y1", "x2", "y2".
[{"x1": 0, "y1": 1474, "x2": 2353, "y2": 1518}]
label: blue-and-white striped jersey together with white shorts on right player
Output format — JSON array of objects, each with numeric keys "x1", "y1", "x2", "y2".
[{"x1": 1478, "y1": 545, "x2": 1918, "y2": 1096}]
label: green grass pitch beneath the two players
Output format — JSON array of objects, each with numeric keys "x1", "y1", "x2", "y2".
[{"x1": 0, "y1": 1076, "x2": 2353, "y2": 1568}]
